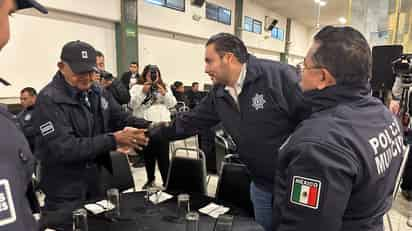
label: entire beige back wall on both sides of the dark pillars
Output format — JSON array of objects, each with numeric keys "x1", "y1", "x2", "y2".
[{"x1": 0, "y1": 0, "x2": 310, "y2": 97}]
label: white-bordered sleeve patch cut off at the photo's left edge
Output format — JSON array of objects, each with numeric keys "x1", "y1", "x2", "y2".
[{"x1": 0, "y1": 179, "x2": 16, "y2": 226}]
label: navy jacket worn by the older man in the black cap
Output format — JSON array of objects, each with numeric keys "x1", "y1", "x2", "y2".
[{"x1": 33, "y1": 72, "x2": 149, "y2": 195}]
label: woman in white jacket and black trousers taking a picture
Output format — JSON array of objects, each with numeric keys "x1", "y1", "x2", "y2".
[{"x1": 130, "y1": 65, "x2": 176, "y2": 189}]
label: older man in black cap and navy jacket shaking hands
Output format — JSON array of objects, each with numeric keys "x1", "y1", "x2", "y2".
[{"x1": 34, "y1": 41, "x2": 149, "y2": 227}]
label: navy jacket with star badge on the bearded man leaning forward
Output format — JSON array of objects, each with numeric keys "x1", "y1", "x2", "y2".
[{"x1": 164, "y1": 55, "x2": 301, "y2": 191}]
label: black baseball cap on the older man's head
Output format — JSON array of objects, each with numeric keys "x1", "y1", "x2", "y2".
[{"x1": 60, "y1": 40, "x2": 98, "y2": 74}]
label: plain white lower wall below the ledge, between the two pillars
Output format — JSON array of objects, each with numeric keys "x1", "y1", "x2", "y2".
[{"x1": 139, "y1": 28, "x2": 211, "y2": 86}]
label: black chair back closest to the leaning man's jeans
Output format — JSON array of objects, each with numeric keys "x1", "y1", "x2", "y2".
[{"x1": 216, "y1": 155, "x2": 254, "y2": 216}]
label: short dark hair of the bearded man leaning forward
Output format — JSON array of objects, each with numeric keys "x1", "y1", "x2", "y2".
[{"x1": 206, "y1": 33, "x2": 249, "y2": 63}]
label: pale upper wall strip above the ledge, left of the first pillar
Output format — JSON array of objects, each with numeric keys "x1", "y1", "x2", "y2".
[{"x1": 38, "y1": 0, "x2": 121, "y2": 21}]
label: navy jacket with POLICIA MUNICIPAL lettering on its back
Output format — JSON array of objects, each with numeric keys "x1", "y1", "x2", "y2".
[{"x1": 273, "y1": 86, "x2": 404, "y2": 231}]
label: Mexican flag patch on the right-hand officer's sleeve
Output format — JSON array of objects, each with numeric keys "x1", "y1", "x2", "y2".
[{"x1": 290, "y1": 176, "x2": 322, "y2": 209}]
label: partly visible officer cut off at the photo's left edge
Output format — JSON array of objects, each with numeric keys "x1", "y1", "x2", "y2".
[{"x1": 0, "y1": 0, "x2": 47, "y2": 231}]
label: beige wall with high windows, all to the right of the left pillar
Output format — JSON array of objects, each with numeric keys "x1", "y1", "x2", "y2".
[{"x1": 138, "y1": 0, "x2": 308, "y2": 85}]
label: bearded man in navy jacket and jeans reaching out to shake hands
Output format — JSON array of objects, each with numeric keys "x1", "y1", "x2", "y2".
[{"x1": 150, "y1": 33, "x2": 302, "y2": 231}]
